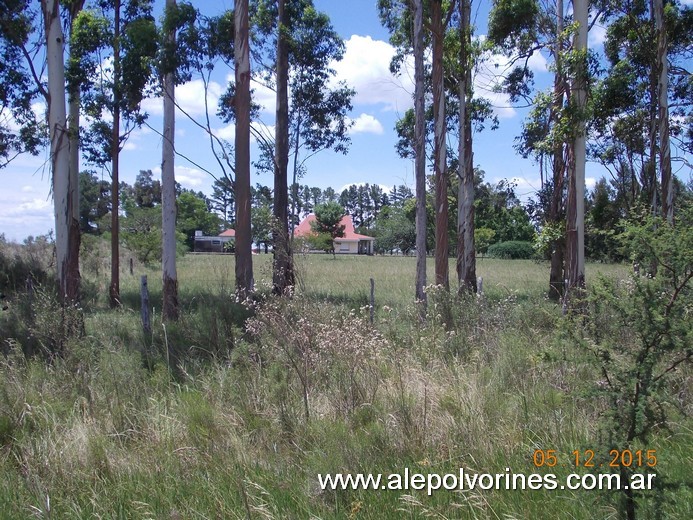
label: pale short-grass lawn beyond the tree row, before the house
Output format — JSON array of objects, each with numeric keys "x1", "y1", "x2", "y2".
[{"x1": 99, "y1": 254, "x2": 629, "y2": 307}]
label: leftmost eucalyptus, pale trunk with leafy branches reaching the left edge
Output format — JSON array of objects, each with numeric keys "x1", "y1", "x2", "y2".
[{"x1": 0, "y1": 0, "x2": 81, "y2": 303}]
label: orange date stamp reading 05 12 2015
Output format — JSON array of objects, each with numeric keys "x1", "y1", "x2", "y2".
[{"x1": 532, "y1": 449, "x2": 657, "y2": 468}]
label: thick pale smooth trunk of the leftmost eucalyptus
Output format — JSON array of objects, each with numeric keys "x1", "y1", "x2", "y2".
[{"x1": 41, "y1": 0, "x2": 72, "y2": 301}]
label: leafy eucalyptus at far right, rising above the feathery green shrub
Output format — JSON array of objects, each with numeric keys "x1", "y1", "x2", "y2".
[{"x1": 590, "y1": 0, "x2": 693, "y2": 225}]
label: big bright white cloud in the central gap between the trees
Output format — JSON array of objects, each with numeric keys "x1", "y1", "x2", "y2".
[{"x1": 331, "y1": 35, "x2": 414, "y2": 112}]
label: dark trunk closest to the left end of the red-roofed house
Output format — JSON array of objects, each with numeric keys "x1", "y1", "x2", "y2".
[{"x1": 270, "y1": 0, "x2": 294, "y2": 294}]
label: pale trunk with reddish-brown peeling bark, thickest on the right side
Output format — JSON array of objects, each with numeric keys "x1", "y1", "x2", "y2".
[{"x1": 567, "y1": 0, "x2": 588, "y2": 309}]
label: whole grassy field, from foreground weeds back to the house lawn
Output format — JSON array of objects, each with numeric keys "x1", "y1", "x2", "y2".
[{"x1": 0, "y1": 250, "x2": 693, "y2": 519}]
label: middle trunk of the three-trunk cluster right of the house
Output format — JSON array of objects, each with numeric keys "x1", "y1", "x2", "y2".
[{"x1": 431, "y1": 0, "x2": 450, "y2": 290}]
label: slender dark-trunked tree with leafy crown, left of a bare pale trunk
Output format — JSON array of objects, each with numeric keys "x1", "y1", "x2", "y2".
[{"x1": 70, "y1": 0, "x2": 157, "y2": 306}]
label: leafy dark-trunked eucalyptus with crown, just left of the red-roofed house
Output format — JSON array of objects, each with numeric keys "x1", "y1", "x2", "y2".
[{"x1": 251, "y1": 0, "x2": 354, "y2": 294}]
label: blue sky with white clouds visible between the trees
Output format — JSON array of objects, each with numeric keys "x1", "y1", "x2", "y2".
[{"x1": 0, "y1": 0, "x2": 688, "y2": 241}]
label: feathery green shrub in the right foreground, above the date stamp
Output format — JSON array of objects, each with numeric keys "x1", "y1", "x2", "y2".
[{"x1": 573, "y1": 207, "x2": 693, "y2": 516}]
